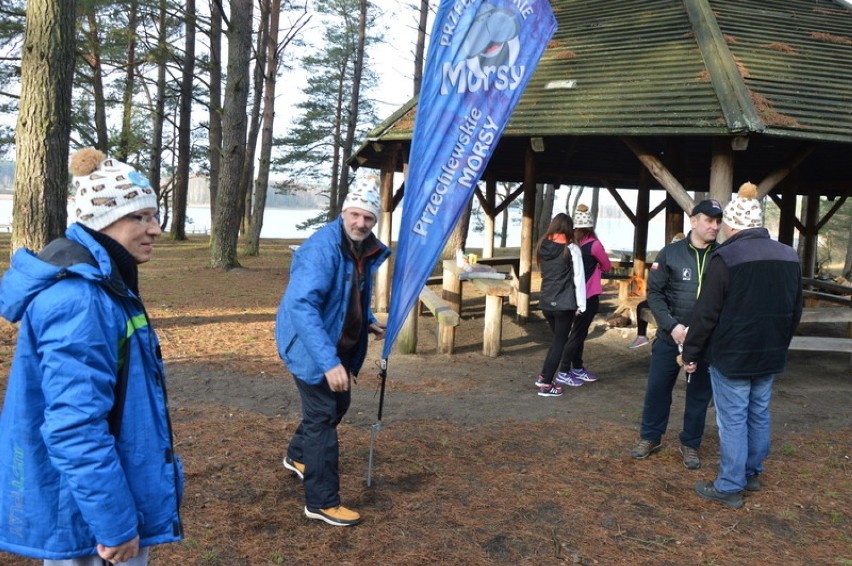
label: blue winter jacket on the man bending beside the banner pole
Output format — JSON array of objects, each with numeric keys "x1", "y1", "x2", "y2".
[{"x1": 275, "y1": 217, "x2": 390, "y2": 385}]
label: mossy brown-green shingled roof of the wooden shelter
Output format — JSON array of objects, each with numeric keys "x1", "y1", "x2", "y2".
[{"x1": 356, "y1": 0, "x2": 852, "y2": 195}]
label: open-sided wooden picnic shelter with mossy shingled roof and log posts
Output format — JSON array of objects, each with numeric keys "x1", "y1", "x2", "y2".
[{"x1": 352, "y1": 0, "x2": 852, "y2": 318}]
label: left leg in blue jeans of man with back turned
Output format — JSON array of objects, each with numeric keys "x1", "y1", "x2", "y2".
[{"x1": 710, "y1": 367, "x2": 751, "y2": 493}]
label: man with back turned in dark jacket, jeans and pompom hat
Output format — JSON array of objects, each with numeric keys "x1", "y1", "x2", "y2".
[{"x1": 683, "y1": 183, "x2": 802, "y2": 509}]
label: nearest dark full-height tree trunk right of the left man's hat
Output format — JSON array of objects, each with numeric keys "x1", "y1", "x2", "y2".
[{"x1": 170, "y1": 0, "x2": 196, "y2": 241}]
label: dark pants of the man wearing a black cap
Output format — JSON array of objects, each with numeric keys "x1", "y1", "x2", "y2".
[{"x1": 640, "y1": 339, "x2": 713, "y2": 450}]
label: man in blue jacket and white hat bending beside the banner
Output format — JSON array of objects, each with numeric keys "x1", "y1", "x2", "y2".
[{"x1": 275, "y1": 178, "x2": 390, "y2": 526}]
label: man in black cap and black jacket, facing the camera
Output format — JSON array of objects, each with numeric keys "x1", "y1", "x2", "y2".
[{"x1": 630, "y1": 200, "x2": 722, "y2": 469}]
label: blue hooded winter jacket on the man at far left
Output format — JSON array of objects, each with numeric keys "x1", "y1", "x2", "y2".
[{"x1": 0, "y1": 224, "x2": 183, "y2": 560}]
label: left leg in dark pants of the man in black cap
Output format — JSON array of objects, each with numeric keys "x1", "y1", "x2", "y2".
[{"x1": 639, "y1": 340, "x2": 680, "y2": 443}]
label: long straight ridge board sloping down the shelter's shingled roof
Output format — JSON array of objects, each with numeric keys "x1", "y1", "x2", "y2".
[{"x1": 683, "y1": 0, "x2": 766, "y2": 132}]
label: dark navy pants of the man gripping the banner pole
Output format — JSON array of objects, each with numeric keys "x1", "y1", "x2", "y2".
[{"x1": 287, "y1": 377, "x2": 352, "y2": 509}]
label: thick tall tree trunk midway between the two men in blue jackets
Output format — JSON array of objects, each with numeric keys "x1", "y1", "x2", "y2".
[{"x1": 210, "y1": 0, "x2": 253, "y2": 269}]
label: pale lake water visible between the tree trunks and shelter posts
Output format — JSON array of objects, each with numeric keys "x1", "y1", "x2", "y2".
[{"x1": 0, "y1": 198, "x2": 680, "y2": 254}]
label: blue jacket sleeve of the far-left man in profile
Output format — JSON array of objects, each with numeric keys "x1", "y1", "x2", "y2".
[{"x1": 30, "y1": 280, "x2": 138, "y2": 546}]
